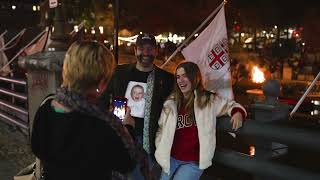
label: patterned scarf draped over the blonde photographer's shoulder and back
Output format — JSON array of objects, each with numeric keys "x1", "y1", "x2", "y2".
[{"x1": 55, "y1": 88, "x2": 148, "y2": 179}]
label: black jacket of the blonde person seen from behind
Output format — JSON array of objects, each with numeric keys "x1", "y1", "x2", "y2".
[{"x1": 31, "y1": 100, "x2": 135, "y2": 180}]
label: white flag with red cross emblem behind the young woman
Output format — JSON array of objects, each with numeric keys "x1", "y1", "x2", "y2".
[{"x1": 182, "y1": 6, "x2": 233, "y2": 99}]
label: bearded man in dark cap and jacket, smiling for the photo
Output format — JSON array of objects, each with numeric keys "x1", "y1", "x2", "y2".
[{"x1": 100, "y1": 33, "x2": 174, "y2": 179}]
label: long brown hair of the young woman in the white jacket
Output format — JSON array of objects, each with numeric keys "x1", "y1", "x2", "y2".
[{"x1": 171, "y1": 61, "x2": 211, "y2": 120}]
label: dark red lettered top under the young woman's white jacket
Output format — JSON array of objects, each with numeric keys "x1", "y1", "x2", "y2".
[{"x1": 171, "y1": 104, "x2": 199, "y2": 161}]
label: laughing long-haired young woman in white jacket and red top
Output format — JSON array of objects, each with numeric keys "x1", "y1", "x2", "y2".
[{"x1": 155, "y1": 62, "x2": 246, "y2": 180}]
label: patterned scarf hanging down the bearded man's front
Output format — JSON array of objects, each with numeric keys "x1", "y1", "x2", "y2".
[{"x1": 143, "y1": 70, "x2": 155, "y2": 154}]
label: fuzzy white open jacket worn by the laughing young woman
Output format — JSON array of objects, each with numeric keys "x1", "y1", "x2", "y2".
[{"x1": 155, "y1": 92, "x2": 246, "y2": 173}]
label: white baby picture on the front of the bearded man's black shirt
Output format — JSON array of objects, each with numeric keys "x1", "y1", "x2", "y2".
[{"x1": 125, "y1": 81, "x2": 147, "y2": 118}]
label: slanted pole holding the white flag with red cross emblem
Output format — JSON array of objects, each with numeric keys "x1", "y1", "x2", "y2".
[{"x1": 161, "y1": 1, "x2": 225, "y2": 68}]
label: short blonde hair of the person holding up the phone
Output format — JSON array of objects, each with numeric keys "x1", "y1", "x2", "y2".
[{"x1": 62, "y1": 41, "x2": 115, "y2": 93}]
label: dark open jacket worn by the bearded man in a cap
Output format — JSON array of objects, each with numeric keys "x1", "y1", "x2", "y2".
[{"x1": 100, "y1": 63, "x2": 174, "y2": 156}]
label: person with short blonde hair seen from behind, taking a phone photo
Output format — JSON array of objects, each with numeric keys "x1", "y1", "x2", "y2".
[{"x1": 31, "y1": 41, "x2": 141, "y2": 180}]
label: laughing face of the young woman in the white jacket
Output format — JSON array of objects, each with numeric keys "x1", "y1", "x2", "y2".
[{"x1": 176, "y1": 67, "x2": 192, "y2": 97}]
